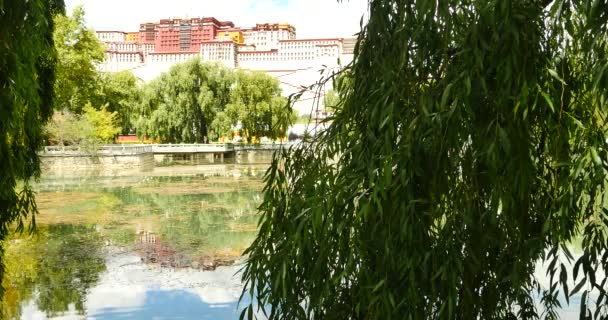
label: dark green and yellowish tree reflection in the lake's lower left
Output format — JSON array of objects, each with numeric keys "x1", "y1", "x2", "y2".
[{"x1": 3, "y1": 225, "x2": 105, "y2": 319}]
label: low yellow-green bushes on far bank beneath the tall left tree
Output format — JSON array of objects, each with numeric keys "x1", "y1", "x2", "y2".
[{"x1": 46, "y1": 103, "x2": 120, "y2": 146}]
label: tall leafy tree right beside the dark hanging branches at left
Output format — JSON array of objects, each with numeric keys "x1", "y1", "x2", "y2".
[{"x1": 54, "y1": 6, "x2": 105, "y2": 113}]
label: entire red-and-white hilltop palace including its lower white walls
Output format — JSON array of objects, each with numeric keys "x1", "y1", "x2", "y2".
[{"x1": 98, "y1": 18, "x2": 356, "y2": 113}]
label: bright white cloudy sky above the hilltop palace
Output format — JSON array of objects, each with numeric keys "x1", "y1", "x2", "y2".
[{"x1": 66, "y1": 0, "x2": 367, "y2": 38}]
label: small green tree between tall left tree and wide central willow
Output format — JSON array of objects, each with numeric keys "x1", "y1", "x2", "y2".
[{"x1": 95, "y1": 71, "x2": 140, "y2": 134}]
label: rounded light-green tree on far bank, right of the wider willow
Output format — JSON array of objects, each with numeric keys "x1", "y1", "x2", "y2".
[{"x1": 226, "y1": 70, "x2": 297, "y2": 138}]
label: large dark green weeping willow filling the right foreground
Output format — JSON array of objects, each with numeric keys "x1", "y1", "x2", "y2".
[{"x1": 243, "y1": 0, "x2": 608, "y2": 319}]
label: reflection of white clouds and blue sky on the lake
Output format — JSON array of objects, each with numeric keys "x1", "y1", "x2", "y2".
[{"x1": 17, "y1": 253, "x2": 249, "y2": 319}]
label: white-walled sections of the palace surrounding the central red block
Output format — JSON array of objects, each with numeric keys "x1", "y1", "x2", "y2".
[{"x1": 97, "y1": 24, "x2": 356, "y2": 115}]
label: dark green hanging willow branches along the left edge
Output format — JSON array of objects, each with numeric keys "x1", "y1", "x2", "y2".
[{"x1": 0, "y1": 0, "x2": 64, "y2": 297}]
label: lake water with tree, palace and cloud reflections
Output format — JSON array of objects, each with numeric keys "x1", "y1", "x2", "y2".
[{"x1": 1, "y1": 165, "x2": 266, "y2": 319}]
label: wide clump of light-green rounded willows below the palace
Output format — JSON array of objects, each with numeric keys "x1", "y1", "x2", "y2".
[{"x1": 135, "y1": 59, "x2": 295, "y2": 143}]
